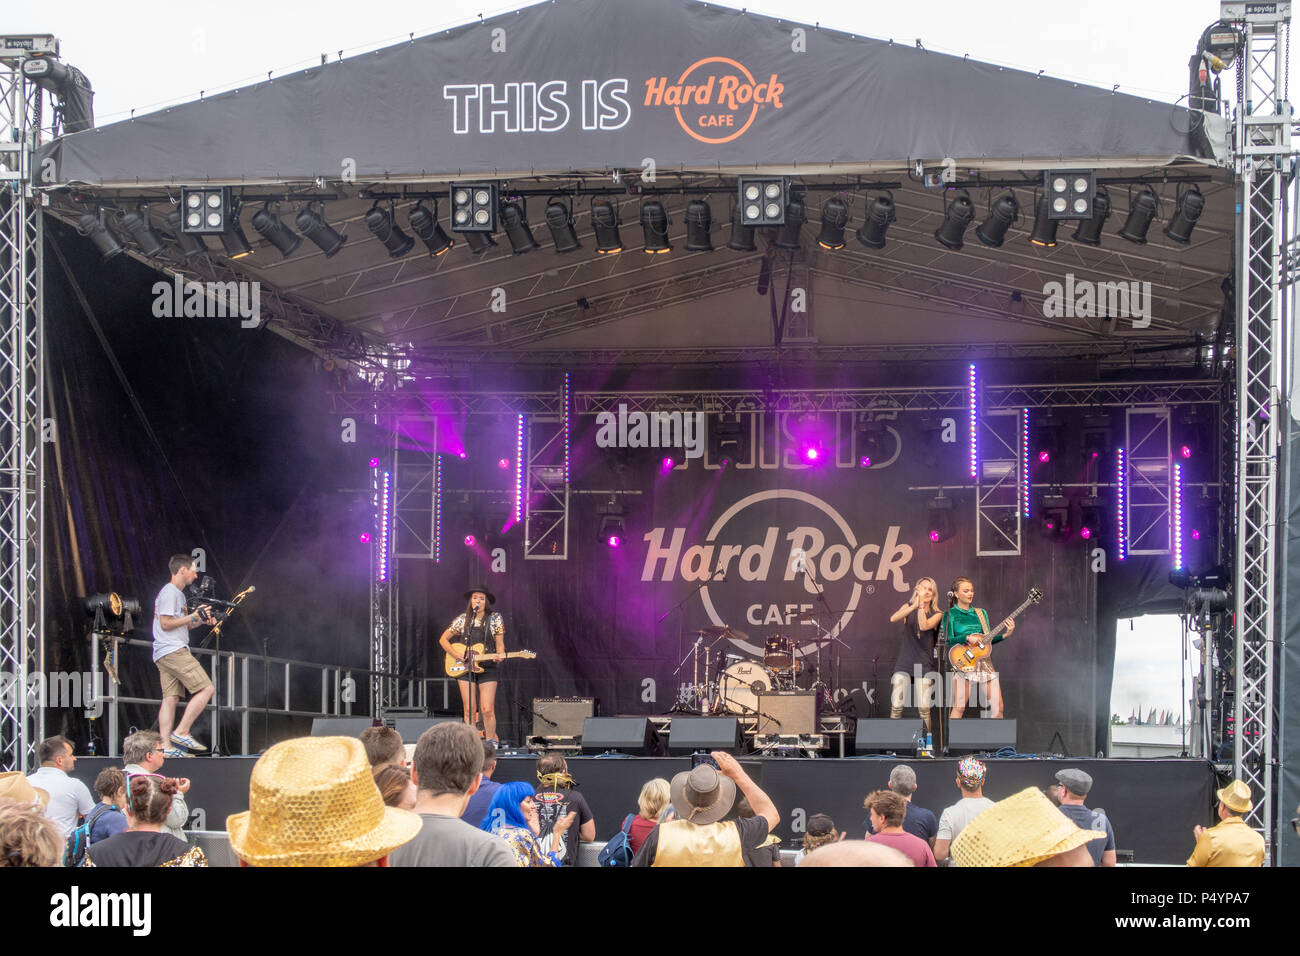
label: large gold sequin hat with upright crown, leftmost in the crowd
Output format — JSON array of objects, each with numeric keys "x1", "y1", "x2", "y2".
[{"x1": 226, "y1": 737, "x2": 421, "y2": 866}]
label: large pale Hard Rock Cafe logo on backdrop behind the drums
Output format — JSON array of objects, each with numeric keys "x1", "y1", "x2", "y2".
[{"x1": 641, "y1": 489, "x2": 913, "y2": 656}]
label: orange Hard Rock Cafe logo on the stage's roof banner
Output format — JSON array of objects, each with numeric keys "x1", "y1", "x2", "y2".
[{"x1": 645, "y1": 56, "x2": 785, "y2": 143}]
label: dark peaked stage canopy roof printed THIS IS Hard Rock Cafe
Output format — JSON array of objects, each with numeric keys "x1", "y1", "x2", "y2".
[{"x1": 36, "y1": 0, "x2": 1232, "y2": 374}]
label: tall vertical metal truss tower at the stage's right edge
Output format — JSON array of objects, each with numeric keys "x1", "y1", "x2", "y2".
[{"x1": 1222, "y1": 3, "x2": 1294, "y2": 844}]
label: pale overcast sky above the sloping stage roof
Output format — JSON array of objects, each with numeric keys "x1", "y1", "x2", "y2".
[{"x1": 10, "y1": 0, "x2": 1248, "y2": 125}]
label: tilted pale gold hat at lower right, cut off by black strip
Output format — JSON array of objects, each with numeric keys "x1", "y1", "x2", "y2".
[{"x1": 950, "y1": 787, "x2": 1106, "y2": 866}]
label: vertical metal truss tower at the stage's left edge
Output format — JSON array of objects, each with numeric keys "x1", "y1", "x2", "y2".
[{"x1": 0, "y1": 38, "x2": 45, "y2": 770}]
